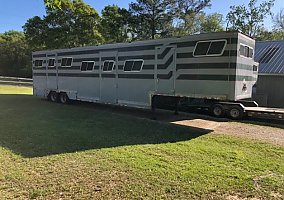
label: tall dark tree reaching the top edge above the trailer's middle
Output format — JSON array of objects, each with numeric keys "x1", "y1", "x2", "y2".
[{"x1": 129, "y1": 0, "x2": 172, "y2": 39}]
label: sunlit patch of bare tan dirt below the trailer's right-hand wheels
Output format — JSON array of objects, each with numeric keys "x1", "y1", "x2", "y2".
[{"x1": 171, "y1": 115, "x2": 284, "y2": 146}]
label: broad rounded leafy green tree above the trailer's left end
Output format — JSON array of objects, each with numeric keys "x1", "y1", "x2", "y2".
[{"x1": 23, "y1": 0, "x2": 102, "y2": 49}]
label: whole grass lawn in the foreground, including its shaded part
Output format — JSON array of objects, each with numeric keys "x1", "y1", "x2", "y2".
[{"x1": 0, "y1": 86, "x2": 284, "y2": 199}]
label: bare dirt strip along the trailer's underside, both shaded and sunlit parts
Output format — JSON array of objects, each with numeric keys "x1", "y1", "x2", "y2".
[{"x1": 71, "y1": 103, "x2": 284, "y2": 146}]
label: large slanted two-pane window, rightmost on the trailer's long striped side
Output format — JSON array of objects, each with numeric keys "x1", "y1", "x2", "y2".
[{"x1": 193, "y1": 40, "x2": 227, "y2": 57}]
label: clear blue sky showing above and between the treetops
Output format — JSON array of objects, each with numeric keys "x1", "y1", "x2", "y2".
[{"x1": 0, "y1": 0, "x2": 284, "y2": 33}]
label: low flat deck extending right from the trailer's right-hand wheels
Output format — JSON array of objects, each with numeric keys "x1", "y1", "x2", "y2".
[{"x1": 244, "y1": 107, "x2": 284, "y2": 120}]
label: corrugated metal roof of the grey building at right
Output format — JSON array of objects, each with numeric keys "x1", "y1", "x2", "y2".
[{"x1": 255, "y1": 40, "x2": 284, "y2": 74}]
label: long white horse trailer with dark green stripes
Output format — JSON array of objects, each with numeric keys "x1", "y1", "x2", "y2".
[{"x1": 32, "y1": 32, "x2": 257, "y2": 118}]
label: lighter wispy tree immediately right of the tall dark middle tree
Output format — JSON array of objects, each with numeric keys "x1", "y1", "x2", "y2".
[{"x1": 172, "y1": 0, "x2": 211, "y2": 35}]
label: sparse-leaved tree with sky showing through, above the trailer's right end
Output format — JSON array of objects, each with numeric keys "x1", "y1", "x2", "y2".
[{"x1": 227, "y1": 0, "x2": 275, "y2": 37}]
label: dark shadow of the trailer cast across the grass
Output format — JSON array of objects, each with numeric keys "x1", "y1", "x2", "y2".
[{"x1": 0, "y1": 95, "x2": 211, "y2": 158}]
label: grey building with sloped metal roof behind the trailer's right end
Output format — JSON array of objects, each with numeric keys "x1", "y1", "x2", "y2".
[{"x1": 254, "y1": 40, "x2": 284, "y2": 108}]
